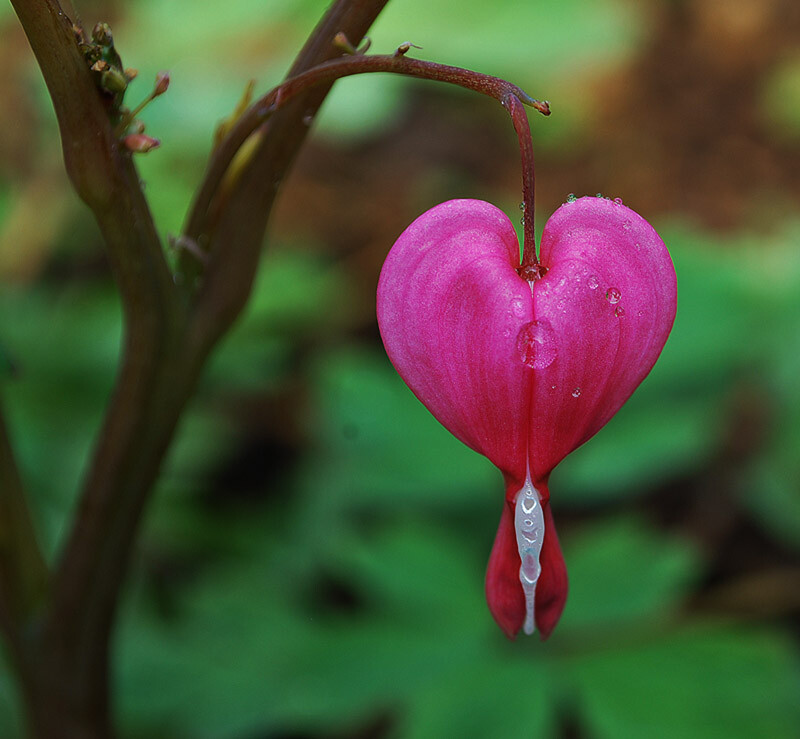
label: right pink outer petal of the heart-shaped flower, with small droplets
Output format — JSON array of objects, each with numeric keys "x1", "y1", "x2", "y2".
[{"x1": 529, "y1": 197, "x2": 676, "y2": 481}]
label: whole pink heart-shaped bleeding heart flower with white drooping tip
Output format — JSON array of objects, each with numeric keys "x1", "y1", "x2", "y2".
[{"x1": 378, "y1": 197, "x2": 676, "y2": 638}]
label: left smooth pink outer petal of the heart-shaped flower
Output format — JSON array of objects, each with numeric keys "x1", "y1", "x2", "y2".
[{"x1": 378, "y1": 200, "x2": 532, "y2": 487}]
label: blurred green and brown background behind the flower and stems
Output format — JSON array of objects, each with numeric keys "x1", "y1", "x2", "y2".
[{"x1": 0, "y1": 0, "x2": 800, "y2": 739}]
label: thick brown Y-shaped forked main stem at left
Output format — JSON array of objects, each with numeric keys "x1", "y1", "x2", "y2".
[{"x1": 12, "y1": 0, "x2": 385, "y2": 737}]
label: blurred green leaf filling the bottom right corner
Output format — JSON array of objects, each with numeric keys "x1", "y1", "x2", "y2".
[{"x1": 569, "y1": 626, "x2": 800, "y2": 739}]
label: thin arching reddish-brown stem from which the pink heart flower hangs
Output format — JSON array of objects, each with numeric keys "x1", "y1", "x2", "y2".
[{"x1": 185, "y1": 42, "x2": 550, "y2": 266}]
